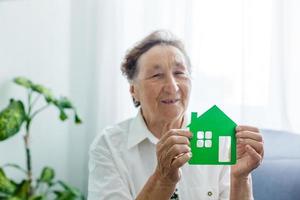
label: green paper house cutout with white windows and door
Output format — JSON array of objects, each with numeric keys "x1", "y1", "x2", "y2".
[{"x1": 188, "y1": 105, "x2": 236, "y2": 165}]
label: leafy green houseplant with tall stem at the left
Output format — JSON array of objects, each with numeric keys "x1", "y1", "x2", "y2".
[{"x1": 0, "y1": 77, "x2": 84, "y2": 200}]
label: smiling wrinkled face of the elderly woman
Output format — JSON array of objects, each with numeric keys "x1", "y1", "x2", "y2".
[{"x1": 130, "y1": 45, "x2": 191, "y2": 122}]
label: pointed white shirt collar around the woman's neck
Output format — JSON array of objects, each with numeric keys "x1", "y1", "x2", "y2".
[{"x1": 127, "y1": 109, "x2": 190, "y2": 149}]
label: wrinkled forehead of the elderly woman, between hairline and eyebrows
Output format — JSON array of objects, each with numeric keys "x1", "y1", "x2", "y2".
[{"x1": 138, "y1": 45, "x2": 186, "y2": 68}]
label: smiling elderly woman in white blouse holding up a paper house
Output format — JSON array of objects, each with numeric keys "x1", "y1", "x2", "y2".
[{"x1": 88, "y1": 31, "x2": 263, "y2": 200}]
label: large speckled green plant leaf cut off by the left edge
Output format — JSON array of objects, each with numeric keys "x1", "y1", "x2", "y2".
[{"x1": 0, "y1": 99, "x2": 26, "y2": 141}]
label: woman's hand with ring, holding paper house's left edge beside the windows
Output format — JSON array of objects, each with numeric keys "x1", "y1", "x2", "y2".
[{"x1": 154, "y1": 129, "x2": 192, "y2": 185}]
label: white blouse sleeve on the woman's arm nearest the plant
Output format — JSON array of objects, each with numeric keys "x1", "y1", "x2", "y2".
[{"x1": 88, "y1": 131, "x2": 133, "y2": 200}]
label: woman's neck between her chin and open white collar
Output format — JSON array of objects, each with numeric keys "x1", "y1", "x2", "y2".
[{"x1": 141, "y1": 110, "x2": 184, "y2": 139}]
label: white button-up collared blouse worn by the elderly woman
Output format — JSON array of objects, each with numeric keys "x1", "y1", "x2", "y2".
[{"x1": 88, "y1": 112, "x2": 230, "y2": 200}]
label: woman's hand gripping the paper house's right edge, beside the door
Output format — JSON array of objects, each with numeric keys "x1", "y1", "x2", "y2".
[{"x1": 231, "y1": 126, "x2": 264, "y2": 179}]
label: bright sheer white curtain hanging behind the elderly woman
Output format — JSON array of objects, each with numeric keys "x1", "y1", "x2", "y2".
[{"x1": 91, "y1": 0, "x2": 300, "y2": 136}]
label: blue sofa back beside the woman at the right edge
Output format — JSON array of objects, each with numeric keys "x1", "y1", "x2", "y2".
[{"x1": 252, "y1": 130, "x2": 300, "y2": 200}]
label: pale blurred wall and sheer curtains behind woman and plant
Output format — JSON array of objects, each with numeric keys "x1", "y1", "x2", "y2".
[{"x1": 0, "y1": 0, "x2": 300, "y2": 197}]
